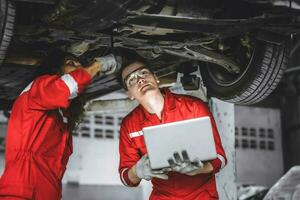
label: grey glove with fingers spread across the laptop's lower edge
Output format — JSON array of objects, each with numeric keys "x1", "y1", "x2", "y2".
[{"x1": 168, "y1": 150, "x2": 203, "y2": 176}]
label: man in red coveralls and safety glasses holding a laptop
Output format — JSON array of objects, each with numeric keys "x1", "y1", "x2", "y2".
[{"x1": 119, "y1": 55, "x2": 227, "y2": 200}]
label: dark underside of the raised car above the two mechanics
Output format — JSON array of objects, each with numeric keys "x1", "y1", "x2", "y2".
[{"x1": 0, "y1": 0, "x2": 300, "y2": 110}]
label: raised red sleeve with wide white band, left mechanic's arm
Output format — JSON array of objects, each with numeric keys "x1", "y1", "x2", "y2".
[{"x1": 28, "y1": 68, "x2": 92, "y2": 110}]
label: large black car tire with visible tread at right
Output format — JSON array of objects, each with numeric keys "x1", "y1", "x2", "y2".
[{"x1": 201, "y1": 40, "x2": 288, "y2": 105}]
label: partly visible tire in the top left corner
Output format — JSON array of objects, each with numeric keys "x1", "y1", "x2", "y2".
[{"x1": 0, "y1": 0, "x2": 15, "y2": 65}]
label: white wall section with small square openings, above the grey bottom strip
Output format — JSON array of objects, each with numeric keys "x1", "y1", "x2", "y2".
[{"x1": 63, "y1": 111, "x2": 127, "y2": 185}]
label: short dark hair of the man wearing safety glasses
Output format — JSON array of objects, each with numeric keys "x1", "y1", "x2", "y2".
[{"x1": 117, "y1": 53, "x2": 153, "y2": 90}]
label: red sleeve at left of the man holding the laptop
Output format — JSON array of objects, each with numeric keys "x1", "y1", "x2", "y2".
[{"x1": 119, "y1": 121, "x2": 140, "y2": 187}]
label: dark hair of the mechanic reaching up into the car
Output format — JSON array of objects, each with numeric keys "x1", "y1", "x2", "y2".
[{"x1": 34, "y1": 48, "x2": 79, "y2": 78}]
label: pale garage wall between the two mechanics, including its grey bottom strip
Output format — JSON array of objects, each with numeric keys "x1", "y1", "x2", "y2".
[{"x1": 63, "y1": 110, "x2": 143, "y2": 200}]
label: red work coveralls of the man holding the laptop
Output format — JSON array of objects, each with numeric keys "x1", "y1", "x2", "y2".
[{"x1": 119, "y1": 90, "x2": 227, "y2": 200}]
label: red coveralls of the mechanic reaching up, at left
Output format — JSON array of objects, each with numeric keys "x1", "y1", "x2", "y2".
[{"x1": 0, "y1": 68, "x2": 92, "y2": 200}]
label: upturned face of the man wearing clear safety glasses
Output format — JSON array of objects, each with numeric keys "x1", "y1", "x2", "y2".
[{"x1": 122, "y1": 62, "x2": 159, "y2": 101}]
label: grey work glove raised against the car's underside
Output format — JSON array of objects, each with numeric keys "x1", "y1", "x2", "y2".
[{"x1": 95, "y1": 54, "x2": 121, "y2": 75}]
